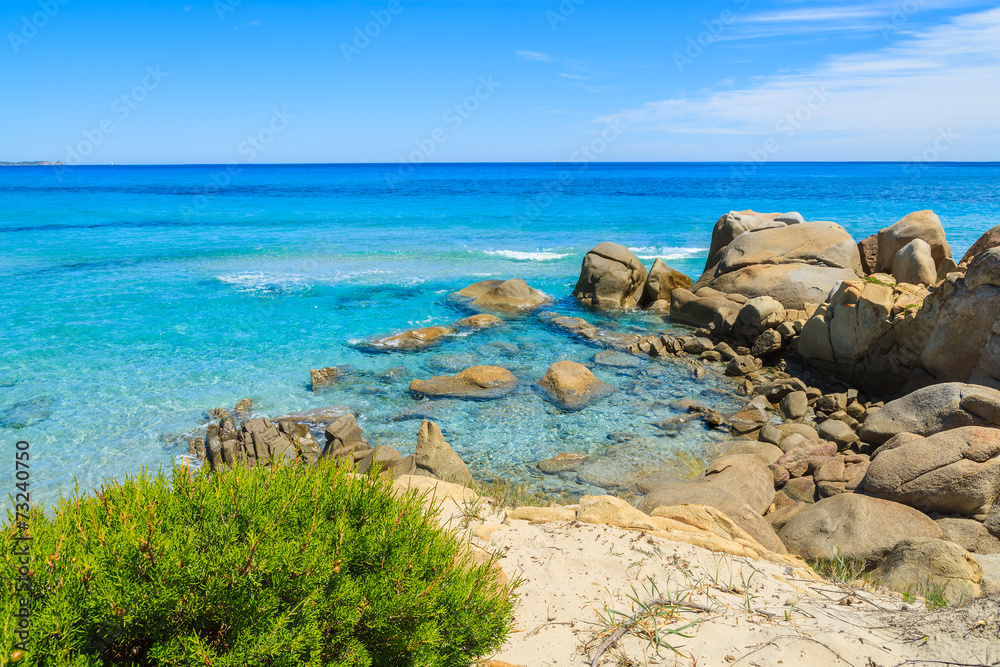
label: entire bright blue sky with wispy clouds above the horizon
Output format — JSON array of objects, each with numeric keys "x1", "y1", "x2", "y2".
[{"x1": 0, "y1": 0, "x2": 1000, "y2": 164}]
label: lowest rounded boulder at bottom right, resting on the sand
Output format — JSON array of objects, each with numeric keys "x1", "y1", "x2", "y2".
[{"x1": 878, "y1": 537, "x2": 983, "y2": 604}]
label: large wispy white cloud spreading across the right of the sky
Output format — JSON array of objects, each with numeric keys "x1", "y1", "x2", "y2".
[{"x1": 608, "y1": 8, "x2": 1000, "y2": 159}]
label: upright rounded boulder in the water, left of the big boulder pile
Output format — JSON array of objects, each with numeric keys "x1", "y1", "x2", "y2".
[{"x1": 573, "y1": 241, "x2": 648, "y2": 308}]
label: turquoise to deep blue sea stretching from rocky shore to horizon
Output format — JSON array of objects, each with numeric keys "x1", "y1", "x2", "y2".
[{"x1": 0, "y1": 163, "x2": 1000, "y2": 504}]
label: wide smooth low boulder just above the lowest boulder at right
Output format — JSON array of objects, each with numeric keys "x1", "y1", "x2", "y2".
[{"x1": 779, "y1": 493, "x2": 941, "y2": 563}]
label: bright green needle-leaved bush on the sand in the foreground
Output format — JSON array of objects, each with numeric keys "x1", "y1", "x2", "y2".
[{"x1": 0, "y1": 462, "x2": 514, "y2": 667}]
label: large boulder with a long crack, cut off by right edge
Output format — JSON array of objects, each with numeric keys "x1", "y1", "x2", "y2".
[{"x1": 864, "y1": 426, "x2": 1000, "y2": 518}]
